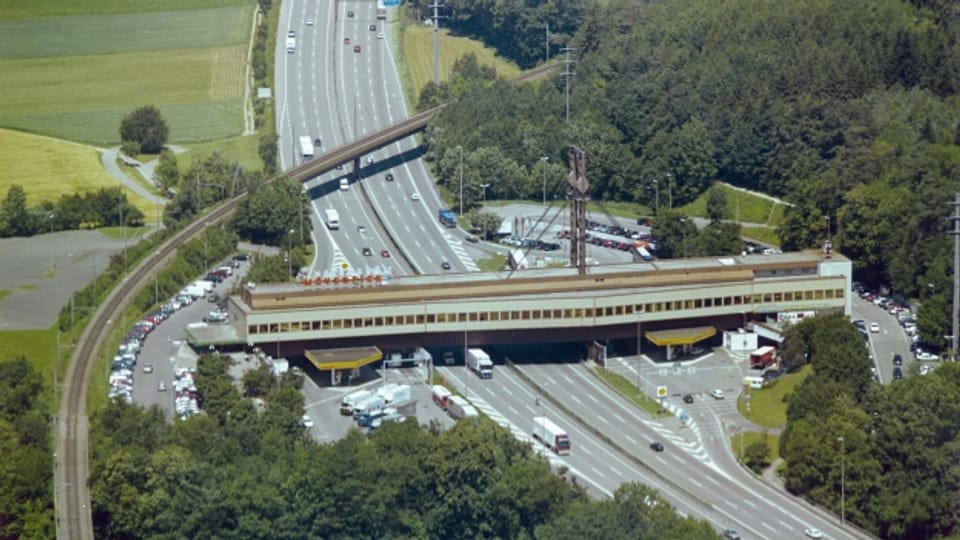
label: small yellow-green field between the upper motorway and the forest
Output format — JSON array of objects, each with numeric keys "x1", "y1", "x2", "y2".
[{"x1": 401, "y1": 25, "x2": 520, "y2": 103}]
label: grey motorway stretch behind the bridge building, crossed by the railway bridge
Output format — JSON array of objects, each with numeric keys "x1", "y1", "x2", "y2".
[{"x1": 275, "y1": 1, "x2": 477, "y2": 276}]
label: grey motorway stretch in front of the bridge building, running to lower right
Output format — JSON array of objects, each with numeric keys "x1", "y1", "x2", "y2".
[{"x1": 440, "y1": 356, "x2": 860, "y2": 538}]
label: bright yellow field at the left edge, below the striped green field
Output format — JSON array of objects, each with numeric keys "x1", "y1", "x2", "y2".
[{"x1": 0, "y1": 129, "x2": 156, "y2": 216}]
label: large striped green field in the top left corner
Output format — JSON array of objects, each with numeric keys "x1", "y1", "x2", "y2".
[{"x1": 0, "y1": 0, "x2": 253, "y2": 145}]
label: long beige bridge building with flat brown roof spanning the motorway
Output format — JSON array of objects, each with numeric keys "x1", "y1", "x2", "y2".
[{"x1": 187, "y1": 251, "x2": 852, "y2": 355}]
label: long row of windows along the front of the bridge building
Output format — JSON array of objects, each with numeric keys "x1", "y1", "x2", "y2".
[{"x1": 247, "y1": 289, "x2": 845, "y2": 334}]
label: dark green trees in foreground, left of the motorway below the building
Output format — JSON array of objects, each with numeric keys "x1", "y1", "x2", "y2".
[{"x1": 82, "y1": 354, "x2": 717, "y2": 540}]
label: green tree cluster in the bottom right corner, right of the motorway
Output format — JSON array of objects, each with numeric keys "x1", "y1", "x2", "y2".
[{"x1": 780, "y1": 316, "x2": 960, "y2": 539}]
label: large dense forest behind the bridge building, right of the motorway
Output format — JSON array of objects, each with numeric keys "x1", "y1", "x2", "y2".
[{"x1": 426, "y1": 0, "x2": 960, "y2": 347}]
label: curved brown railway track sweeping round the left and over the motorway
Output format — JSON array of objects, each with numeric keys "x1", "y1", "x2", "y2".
[{"x1": 54, "y1": 64, "x2": 556, "y2": 540}]
